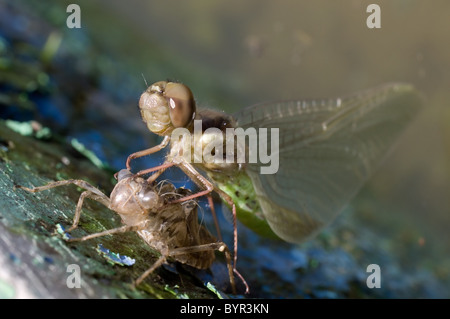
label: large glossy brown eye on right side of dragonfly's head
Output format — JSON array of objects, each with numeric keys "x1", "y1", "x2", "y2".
[{"x1": 165, "y1": 82, "x2": 195, "y2": 128}]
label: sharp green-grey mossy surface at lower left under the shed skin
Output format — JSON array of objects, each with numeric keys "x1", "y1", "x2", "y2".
[{"x1": 0, "y1": 122, "x2": 220, "y2": 298}]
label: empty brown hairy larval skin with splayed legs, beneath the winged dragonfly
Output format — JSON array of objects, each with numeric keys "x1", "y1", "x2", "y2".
[{"x1": 17, "y1": 169, "x2": 239, "y2": 293}]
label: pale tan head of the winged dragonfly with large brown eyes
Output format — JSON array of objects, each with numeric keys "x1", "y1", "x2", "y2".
[{"x1": 139, "y1": 81, "x2": 195, "y2": 135}]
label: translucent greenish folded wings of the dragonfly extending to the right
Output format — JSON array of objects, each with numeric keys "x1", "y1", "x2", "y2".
[{"x1": 234, "y1": 83, "x2": 422, "y2": 243}]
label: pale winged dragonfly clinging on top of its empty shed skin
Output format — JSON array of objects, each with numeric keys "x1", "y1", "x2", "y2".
[{"x1": 127, "y1": 81, "x2": 422, "y2": 245}]
